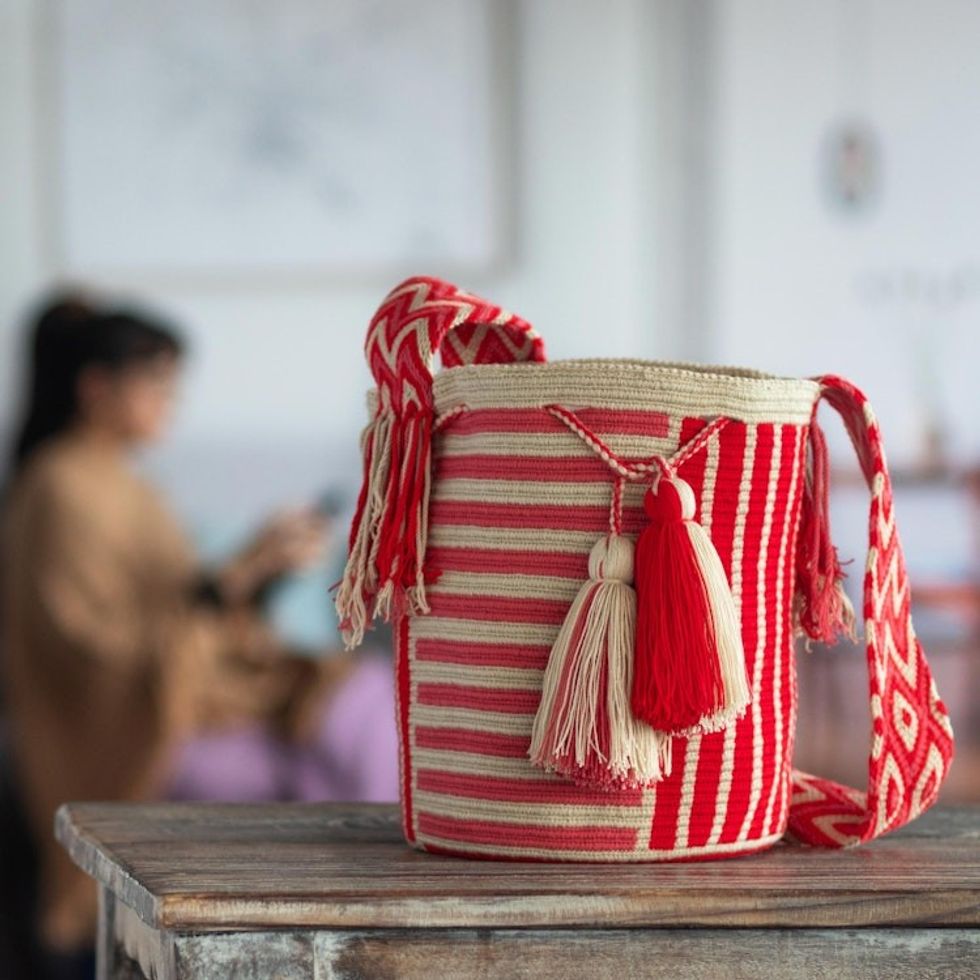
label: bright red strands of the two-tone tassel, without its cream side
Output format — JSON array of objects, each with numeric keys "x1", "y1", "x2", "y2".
[{"x1": 632, "y1": 479, "x2": 725, "y2": 732}]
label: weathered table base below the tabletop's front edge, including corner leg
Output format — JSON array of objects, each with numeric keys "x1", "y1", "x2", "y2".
[{"x1": 103, "y1": 929, "x2": 980, "y2": 980}]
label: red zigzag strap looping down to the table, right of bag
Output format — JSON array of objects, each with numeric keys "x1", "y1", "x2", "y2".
[{"x1": 789, "y1": 375, "x2": 953, "y2": 847}]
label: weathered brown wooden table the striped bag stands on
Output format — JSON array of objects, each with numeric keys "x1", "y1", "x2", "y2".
[{"x1": 57, "y1": 803, "x2": 980, "y2": 980}]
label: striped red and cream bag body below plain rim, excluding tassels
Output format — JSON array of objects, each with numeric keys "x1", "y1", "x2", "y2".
[{"x1": 398, "y1": 408, "x2": 806, "y2": 860}]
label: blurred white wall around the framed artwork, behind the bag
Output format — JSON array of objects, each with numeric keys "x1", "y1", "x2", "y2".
[{"x1": 0, "y1": 0, "x2": 980, "y2": 528}]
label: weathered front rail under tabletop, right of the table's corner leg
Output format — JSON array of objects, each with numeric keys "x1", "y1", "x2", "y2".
[{"x1": 314, "y1": 929, "x2": 980, "y2": 980}]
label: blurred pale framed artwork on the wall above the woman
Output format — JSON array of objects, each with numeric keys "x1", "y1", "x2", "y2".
[{"x1": 41, "y1": 0, "x2": 508, "y2": 280}]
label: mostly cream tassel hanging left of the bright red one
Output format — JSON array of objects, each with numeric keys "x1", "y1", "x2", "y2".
[{"x1": 528, "y1": 534, "x2": 670, "y2": 790}]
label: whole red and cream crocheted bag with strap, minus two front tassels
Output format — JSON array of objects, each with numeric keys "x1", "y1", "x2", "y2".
[{"x1": 339, "y1": 279, "x2": 952, "y2": 861}]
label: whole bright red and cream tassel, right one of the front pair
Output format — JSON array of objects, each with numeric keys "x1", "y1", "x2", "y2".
[{"x1": 631, "y1": 475, "x2": 749, "y2": 734}]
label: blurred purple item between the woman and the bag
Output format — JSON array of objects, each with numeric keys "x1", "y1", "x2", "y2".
[{"x1": 166, "y1": 656, "x2": 398, "y2": 802}]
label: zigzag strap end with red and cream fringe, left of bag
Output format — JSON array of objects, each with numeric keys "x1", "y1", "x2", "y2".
[{"x1": 337, "y1": 276, "x2": 545, "y2": 648}]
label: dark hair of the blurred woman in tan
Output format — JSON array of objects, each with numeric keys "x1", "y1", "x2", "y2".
[{"x1": 9, "y1": 294, "x2": 183, "y2": 476}]
